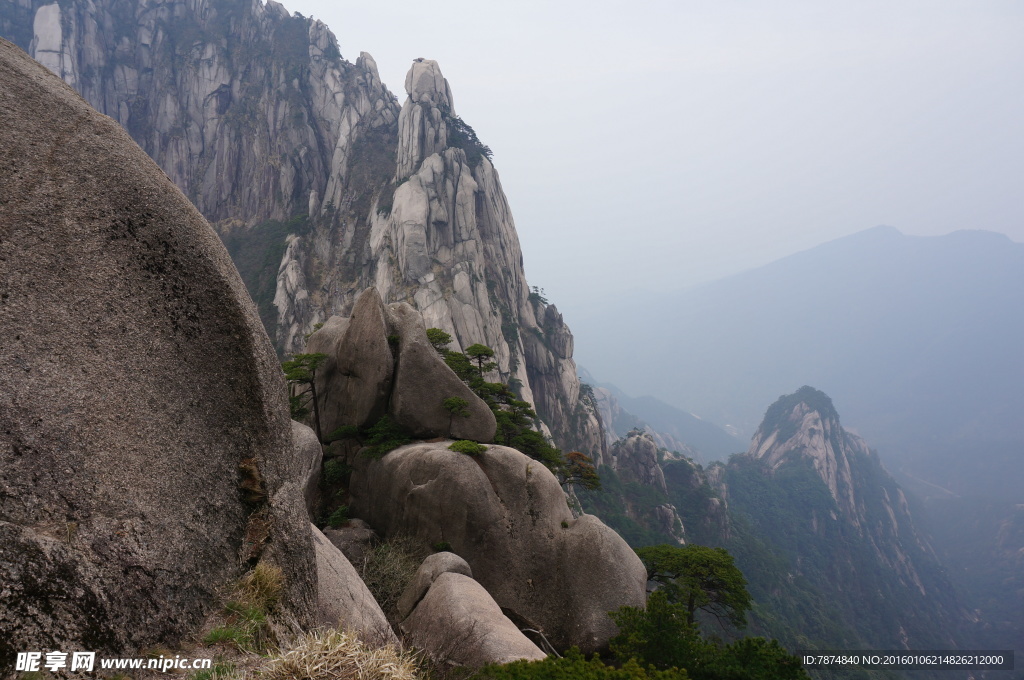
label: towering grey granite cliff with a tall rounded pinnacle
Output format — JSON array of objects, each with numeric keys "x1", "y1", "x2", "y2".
[{"x1": 0, "y1": 0, "x2": 605, "y2": 458}]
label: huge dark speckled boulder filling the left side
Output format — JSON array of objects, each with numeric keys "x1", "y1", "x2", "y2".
[{"x1": 0, "y1": 40, "x2": 316, "y2": 669}]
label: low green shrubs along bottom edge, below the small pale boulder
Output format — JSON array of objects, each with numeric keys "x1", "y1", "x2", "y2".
[{"x1": 475, "y1": 647, "x2": 688, "y2": 680}]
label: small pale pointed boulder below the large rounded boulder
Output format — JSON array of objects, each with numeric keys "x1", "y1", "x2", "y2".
[{"x1": 401, "y1": 571, "x2": 547, "y2": 667}]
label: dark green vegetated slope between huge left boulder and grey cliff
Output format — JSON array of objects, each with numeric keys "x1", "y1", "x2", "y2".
[{"x1": 221, "y1": 215, "x2": 309, "y2": 338}]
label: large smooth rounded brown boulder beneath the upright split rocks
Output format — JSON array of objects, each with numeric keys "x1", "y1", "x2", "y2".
[{"x1": 350, "y1": 441, "x2": 647, "y2": 651}]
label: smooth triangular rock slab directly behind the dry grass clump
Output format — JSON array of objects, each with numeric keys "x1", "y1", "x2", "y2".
[{"x1": 309, "y1": 524, "x2": 398, "y2": 645}]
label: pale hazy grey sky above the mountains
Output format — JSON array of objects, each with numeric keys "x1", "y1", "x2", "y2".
[{"x1": 285, "y1": 0, "x2": 1024, "y2": 313}]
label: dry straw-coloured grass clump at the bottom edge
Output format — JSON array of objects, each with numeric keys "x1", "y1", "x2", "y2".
[{"x1": 260, "y1": 630, "x2": 419, "y2": 680}]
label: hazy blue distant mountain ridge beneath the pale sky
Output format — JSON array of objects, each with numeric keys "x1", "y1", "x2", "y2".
[{"x1": 580, "y1": 226, "x2": 1024, "y2": 502}]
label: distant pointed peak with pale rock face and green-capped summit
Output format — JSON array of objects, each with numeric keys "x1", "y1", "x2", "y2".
[{"x1": 713, "y1": 387, "x2": 967, "y2": 648}]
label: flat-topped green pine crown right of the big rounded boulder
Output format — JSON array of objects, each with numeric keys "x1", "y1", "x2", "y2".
[{"x1": 636, "y1": 543, "x2": 751, "y2": 628}]
